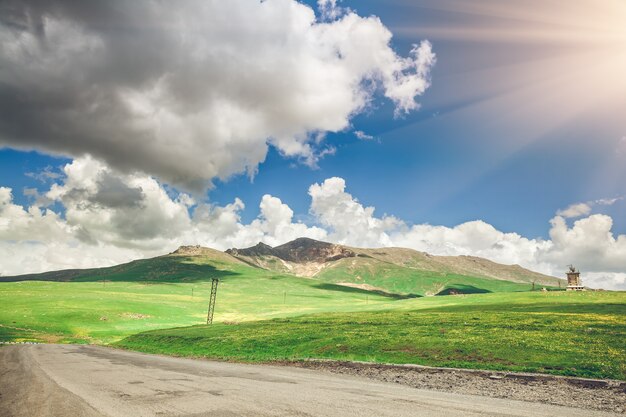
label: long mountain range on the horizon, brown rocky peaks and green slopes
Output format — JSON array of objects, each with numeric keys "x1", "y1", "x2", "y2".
[{"x1": 0, "y1": 238, "x2": 565, "y2": 297}]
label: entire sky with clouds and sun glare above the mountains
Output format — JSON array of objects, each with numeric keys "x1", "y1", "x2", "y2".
[{"x1": 0, "y1": 0, "x2": 626, "y2": 289}]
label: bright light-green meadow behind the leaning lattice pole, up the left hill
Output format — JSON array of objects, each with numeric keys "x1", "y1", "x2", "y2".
[{"x1": 0, "y1": 258, "x2": 396, "y2": 343}]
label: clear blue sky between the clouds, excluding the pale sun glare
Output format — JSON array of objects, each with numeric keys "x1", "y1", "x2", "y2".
[{"x1": 0, "y1": 1, "x2": 626, "y2": 238}]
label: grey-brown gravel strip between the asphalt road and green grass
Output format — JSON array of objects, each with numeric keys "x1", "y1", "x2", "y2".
[{"x1": 283, "y1": 360, "x2": 626, "y2": 414}]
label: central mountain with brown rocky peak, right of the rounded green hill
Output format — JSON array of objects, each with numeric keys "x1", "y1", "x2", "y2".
[{"x1": 226, "y1": 238, "x2": 565, "y2": 294}]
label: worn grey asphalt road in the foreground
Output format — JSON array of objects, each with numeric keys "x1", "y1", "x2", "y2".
[{"x1": 0, "y1": 345, "x2": 614, "y2": 417}]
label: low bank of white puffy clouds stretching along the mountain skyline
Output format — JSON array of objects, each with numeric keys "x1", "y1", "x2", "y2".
[{"x1": 0, "y1": 166, "x2": 626, "y2": 289}]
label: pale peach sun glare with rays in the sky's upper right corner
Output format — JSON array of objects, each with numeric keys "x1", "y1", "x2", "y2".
[{"x1": 399, "y1": 0, "x2": 626, "y2": 139}]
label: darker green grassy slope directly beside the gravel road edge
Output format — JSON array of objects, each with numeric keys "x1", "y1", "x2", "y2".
[{"x1": 117, "y1": 292, "x2": 626, "y2": 379}]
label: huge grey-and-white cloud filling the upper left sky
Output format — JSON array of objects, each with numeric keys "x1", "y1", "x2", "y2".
[{"x1": 0, "y1": 0, "x2": 435, "y2": 190}]
